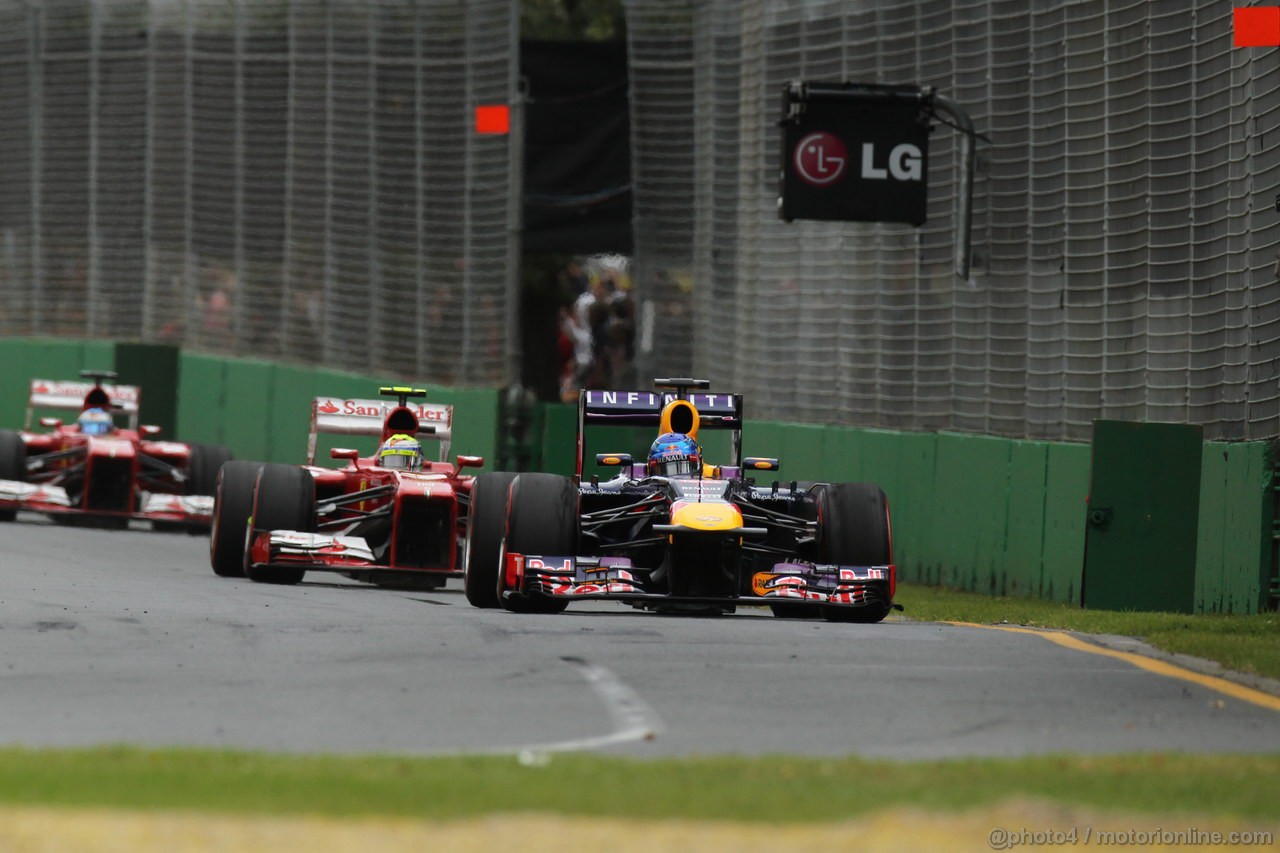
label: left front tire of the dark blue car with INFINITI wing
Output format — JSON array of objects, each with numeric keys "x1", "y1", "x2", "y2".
[{"x1": 498, "y1": 474, "x2": 579, "y2": 613}]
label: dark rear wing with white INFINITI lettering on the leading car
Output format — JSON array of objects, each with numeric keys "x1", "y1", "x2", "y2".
[{"x1": 577, "y1": 379, "x2": 742, "y2": 479}]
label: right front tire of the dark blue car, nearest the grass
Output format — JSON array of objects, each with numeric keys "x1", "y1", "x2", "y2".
[{"x1": 818, "y1": 483, "x2": 893, "y2": 622}]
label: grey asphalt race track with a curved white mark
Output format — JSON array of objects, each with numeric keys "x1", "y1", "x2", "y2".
[{"x1": 0, "y1": 516, "x2": 1280, "y2": 758}]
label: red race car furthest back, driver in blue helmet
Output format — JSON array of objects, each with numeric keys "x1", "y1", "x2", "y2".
[{"x1": 0, "y1": 370, "x2": 230, "y2": 533}]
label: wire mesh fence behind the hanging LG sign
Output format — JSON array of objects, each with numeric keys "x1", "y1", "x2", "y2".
[{"x1": 627, "y1": 0, "x2": 1280, "y2": 439}]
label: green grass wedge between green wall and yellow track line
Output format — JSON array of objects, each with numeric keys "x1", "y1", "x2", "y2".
[{"x1": 895, "y1": 584, "x2": 1280, "y2": 679}]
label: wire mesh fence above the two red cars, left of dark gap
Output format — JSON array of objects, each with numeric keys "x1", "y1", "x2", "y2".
[{"x1": 0, "y1": 0, "x2": 518, "y2": 384}]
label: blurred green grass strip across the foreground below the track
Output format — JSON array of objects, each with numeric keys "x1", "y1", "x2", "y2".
[{"x1": 0, "y1": 748, "x2": 1280, "y2": 824}]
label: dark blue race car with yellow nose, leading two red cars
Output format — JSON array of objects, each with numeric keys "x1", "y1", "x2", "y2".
[{"x1": 465, "y1": 379, "x2": 896, "y2": 622}]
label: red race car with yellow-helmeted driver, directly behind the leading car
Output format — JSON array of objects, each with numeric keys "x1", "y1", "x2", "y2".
[{"x1": 210, "y1": 387, "x2": 484, "y2": 589}]
